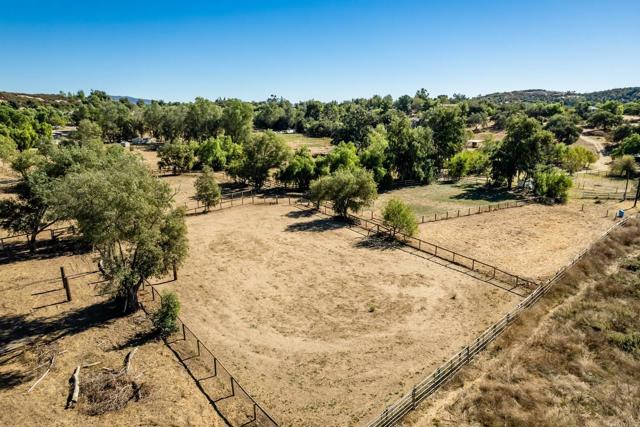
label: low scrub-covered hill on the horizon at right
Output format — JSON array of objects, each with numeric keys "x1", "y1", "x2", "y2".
[{"x1": 476, "y1": 87, "x2": 640, "y2": 103}]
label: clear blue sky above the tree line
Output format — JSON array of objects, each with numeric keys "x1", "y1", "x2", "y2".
[{"x1": 0, "y1": 0, "x2": 640, "y2": 101}]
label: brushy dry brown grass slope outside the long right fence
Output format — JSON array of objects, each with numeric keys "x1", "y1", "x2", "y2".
[{"x1": 401, "y1": 220, "x2": 640, "y2": 427}]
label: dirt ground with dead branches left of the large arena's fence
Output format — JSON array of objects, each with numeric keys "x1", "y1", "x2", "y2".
[{"x1": 0, "y1": 252, "x2": 224, "y2": 427}]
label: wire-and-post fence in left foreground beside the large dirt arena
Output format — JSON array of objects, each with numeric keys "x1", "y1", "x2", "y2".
[{"x1": 141, "y1": 283, "x2": 278, "y2": 427}]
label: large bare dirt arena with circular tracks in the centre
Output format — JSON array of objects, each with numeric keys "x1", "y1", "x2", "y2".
[{"x1": 152, "y1": 205, "x2": 519, "y2": 426}]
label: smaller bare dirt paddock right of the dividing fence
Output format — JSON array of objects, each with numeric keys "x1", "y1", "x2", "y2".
[{"x1": 419, "y1": 200, "x2": 631, "y2": 281}]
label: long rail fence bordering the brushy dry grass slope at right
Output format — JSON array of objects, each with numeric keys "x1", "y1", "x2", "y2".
[{"x1": 365, "y1": 215, "x2": 637, "y2": 427}]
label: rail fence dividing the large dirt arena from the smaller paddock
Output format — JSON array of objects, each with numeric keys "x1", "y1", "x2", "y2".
[{"x1": 303, "y1": 202, "x2": 538, "y2": 290}]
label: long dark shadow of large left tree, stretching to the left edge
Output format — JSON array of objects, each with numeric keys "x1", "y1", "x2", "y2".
[{"x1": 0, "y1": 300, "x2": 122, "y2": 354}]
